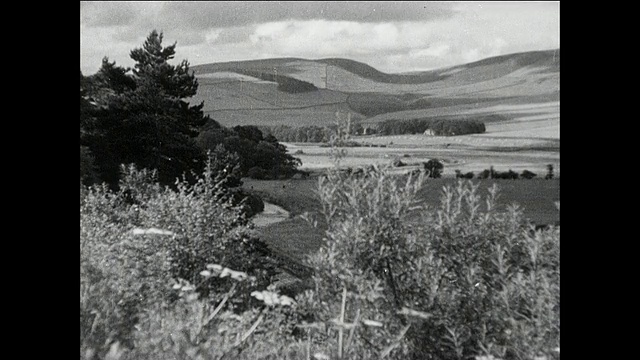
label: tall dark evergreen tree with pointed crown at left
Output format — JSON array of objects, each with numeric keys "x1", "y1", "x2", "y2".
[{"x1": 81, "y1": 30, "x2": 209, "y2": 186}]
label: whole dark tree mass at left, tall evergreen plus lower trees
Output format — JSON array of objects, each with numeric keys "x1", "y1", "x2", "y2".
[{"x1": 80, "y1": 30, "x2": 300, "y2": 193}]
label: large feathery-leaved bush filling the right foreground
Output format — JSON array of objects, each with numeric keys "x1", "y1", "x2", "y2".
[{"x1": 296, "y1": 168, "x2": 559, "y2": 359}]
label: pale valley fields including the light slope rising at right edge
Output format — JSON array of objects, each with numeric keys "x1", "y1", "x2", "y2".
[{"x1": 285, "y1": 102, "x2": 560, "y2": 176}]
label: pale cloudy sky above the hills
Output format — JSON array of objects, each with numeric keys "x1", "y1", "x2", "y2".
[{"x1": 80, "y1": 1, "x2": 560, "y2": 75}]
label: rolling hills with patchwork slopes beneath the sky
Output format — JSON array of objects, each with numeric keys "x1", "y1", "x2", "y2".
[{"x1": 191, "y1": 49, "x2": 560, "y2": 126}]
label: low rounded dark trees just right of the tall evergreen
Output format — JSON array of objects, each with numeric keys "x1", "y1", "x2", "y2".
[{"x1": 197, "y1": 124, "x2": 301, "y2": 180}]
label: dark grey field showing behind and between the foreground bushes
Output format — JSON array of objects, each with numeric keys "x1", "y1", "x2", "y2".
[{"x1": 243, "y1": 177, "x2": 560, "y2": 261}]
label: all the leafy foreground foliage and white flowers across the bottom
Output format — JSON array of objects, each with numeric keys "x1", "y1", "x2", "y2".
[{"x1": 81, "y1": 150, "x2": 560, "y2": 359}]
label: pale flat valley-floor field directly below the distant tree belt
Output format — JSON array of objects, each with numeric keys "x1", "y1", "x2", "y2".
[{"x1": 285, "y1": 132, "x2": 560, "y2": 177}]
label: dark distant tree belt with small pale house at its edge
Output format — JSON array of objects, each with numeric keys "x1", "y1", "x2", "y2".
[{"x1": 378, "y1": 118, "x2": 486, "y2": 136}]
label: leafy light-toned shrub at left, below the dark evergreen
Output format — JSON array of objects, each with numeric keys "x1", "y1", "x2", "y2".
[{"x1": 80, "y1": 162, "x2": 275, "y2": 355}]
